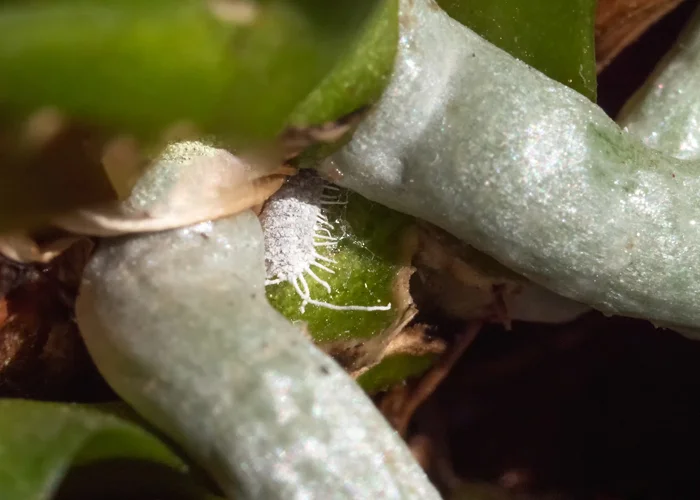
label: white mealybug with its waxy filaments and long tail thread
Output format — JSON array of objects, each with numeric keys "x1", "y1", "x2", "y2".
[{"x1": 260, "y1": 171, "x2": 391, "y2": 313}]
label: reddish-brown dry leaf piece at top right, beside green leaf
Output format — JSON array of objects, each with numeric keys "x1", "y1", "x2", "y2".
[{"x1": 595, "y1": 0, "x2": 683, "y2": 73}]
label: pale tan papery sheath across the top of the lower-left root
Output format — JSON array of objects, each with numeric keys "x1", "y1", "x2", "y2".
[{"x1": 53, "y1": 141, "x2": 296, "y2": 237}]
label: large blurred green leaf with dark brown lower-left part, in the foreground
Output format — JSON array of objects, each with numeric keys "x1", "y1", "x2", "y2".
[{"x1": 0, "y1": 0, "x2": 380, "y2": 230}]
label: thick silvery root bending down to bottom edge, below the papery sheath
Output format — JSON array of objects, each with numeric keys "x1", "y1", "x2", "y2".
[{"x1": 76, "y1": 212, "x2": 440, "y2": 500}]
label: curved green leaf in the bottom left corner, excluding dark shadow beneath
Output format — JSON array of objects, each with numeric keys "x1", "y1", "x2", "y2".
[{"x1": 0, "y1": 400, "x2": 215, "y2": 500}]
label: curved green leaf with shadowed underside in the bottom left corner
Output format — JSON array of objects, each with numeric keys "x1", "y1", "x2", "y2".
[{"x1": 0, "y1": 400, "x2": 217, "y2": 500}]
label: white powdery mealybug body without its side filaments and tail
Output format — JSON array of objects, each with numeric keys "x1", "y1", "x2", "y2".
[{"x1": 260, "y1": 171, "x2": 324, "y2": 280}]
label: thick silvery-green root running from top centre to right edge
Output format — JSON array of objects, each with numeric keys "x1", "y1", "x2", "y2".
[{"x1": 322, "y1": 0, "x2": 700, "y2": 334}]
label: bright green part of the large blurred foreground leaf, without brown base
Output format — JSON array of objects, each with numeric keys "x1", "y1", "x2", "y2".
[{"x1": 0, "y1": 0, "x2": 378, "y2": 143}]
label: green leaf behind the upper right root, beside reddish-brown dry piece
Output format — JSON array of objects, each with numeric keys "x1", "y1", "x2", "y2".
[{"x1": 437, "y1": 0, "x2": 596, "y2": 101}]
